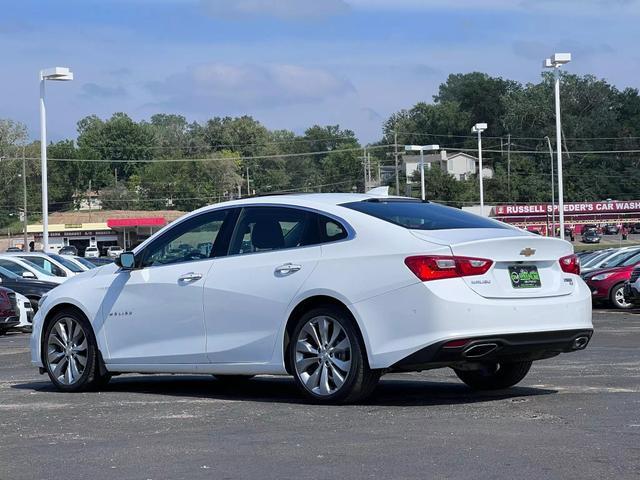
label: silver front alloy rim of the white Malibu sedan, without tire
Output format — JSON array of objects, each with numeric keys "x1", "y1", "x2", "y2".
[{"x1": 47, "y1": 317, "x2": 89, "y2": 385}]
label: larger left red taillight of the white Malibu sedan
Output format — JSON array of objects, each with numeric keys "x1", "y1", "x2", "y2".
[{"x1": 404, "y1": 255, "x2": 493, "y2": 282}]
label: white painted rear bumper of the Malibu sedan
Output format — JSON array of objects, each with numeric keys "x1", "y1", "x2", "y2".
[{"x1": 350, "y1": 275, "x2": 593, "y2": 369}]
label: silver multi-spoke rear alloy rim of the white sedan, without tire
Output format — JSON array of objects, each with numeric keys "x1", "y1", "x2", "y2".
[{"x1": 295, "y1": 316, "x2": 352, "y2": 397}]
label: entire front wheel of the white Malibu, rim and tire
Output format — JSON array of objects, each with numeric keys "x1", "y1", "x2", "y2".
[{"x1": 43, "y1": 310, "x2": 110, "y2": 392}]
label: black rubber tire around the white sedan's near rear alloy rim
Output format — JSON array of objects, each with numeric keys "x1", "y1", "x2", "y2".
[{"x1": 287, "y1": 305, "x2": 381, "y2": 404}]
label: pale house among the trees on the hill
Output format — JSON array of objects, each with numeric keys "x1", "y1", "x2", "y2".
[{"x1": 402, "y1": 150, "x2": 493, "y2": 183}]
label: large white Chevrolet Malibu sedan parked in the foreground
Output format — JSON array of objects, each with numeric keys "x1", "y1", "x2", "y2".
[{"x1": 31, "y1": 194, "x2": 593, "y2": 403}]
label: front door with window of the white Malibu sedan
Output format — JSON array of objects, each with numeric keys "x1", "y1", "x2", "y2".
[{"x1": 102, "y1": 210, "x2": 229, "y2": 364}]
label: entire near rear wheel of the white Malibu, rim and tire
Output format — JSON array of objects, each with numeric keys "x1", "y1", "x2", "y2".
[{"x1": 289, "y1": 305, "x2": 380, "y2": 403}]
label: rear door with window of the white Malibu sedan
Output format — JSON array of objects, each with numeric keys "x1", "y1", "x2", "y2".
[{"x1": 204, "y1": 206, "x2": 321, "y2": 363}]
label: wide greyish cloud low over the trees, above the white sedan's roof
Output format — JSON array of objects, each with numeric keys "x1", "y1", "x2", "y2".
[{"x1": 147, "y1": 63, "x2": 355, "y2": 111}]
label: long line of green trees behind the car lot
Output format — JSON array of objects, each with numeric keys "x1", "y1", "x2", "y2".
[{"x1": 0, "y1": 72, "x2": 640, "y2": 231}]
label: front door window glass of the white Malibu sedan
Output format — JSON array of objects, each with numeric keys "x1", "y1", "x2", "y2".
[{"x1": 141, "y1": 210, "x2": 228, "y2": 267}]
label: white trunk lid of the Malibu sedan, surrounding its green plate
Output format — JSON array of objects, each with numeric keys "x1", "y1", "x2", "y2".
[{"x1": 412, "y1": 228, "x2": 575, "y2": 298}]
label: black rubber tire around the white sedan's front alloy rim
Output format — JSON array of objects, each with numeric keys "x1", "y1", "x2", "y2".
[{"x1": 42, "y1": 309, "x2": 111, "y2": 392}]
